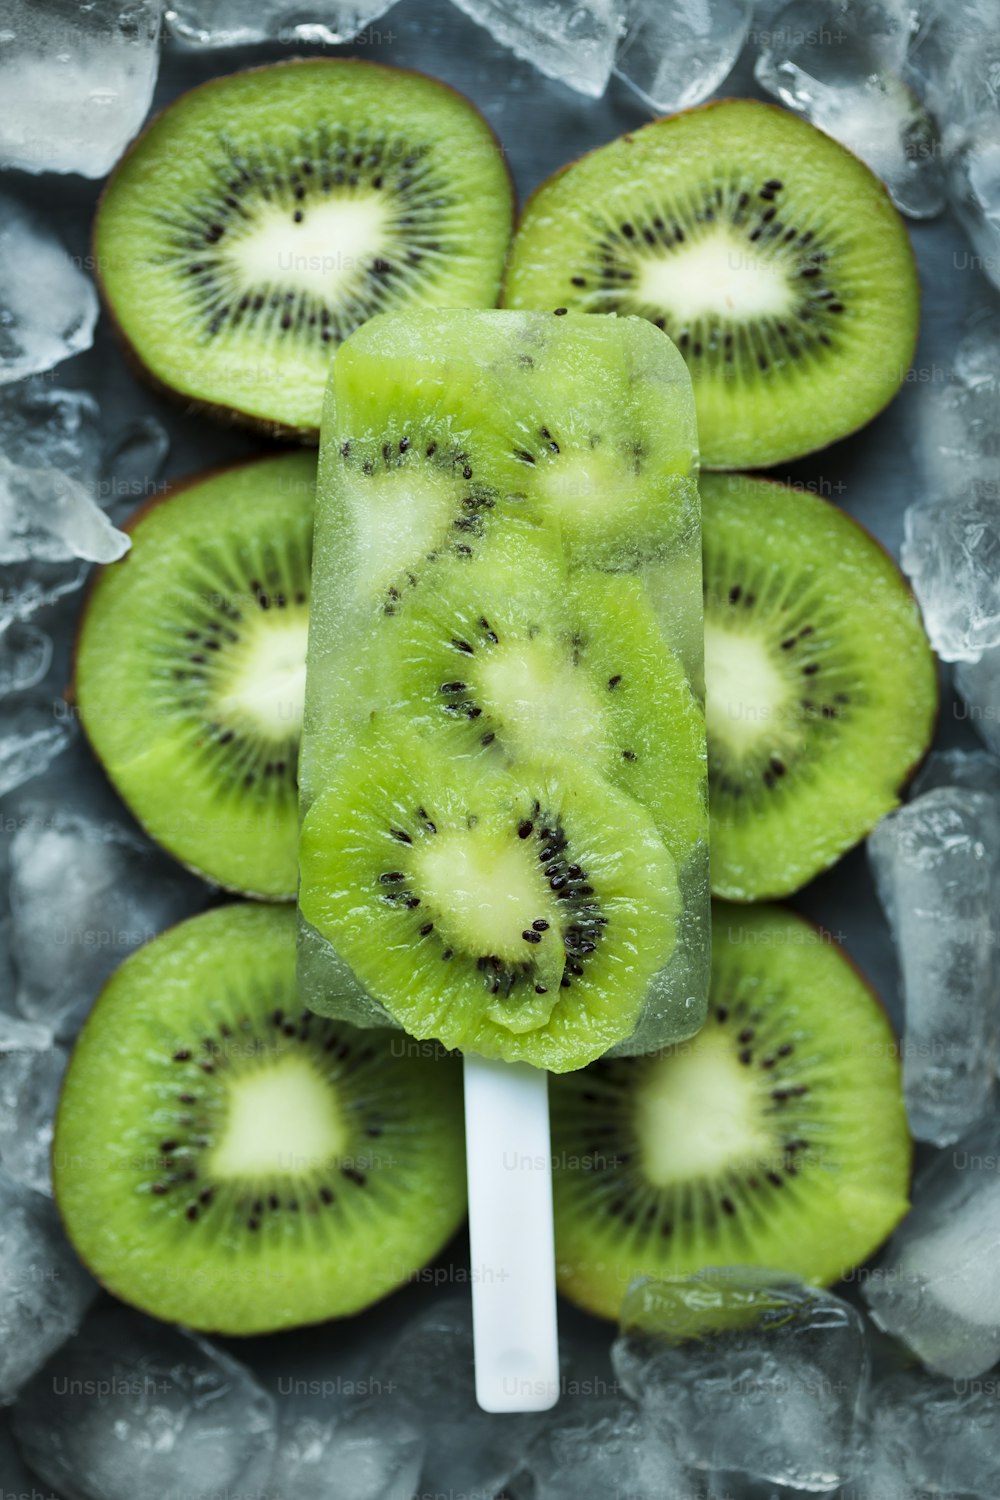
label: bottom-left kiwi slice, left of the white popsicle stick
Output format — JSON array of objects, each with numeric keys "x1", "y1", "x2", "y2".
[{"x1": 52, "y1": 905, "x2": 465, "y2": 1334}]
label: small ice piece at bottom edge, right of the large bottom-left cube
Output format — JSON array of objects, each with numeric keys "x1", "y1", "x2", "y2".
[{"x1": 267, "y1": 1401, "x2": 424, "y2": 1500}]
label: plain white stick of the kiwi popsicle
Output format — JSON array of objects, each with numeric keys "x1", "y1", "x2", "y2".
[{"x1": 465, "y1": 1058, "x2": 559, "y2": 1412}]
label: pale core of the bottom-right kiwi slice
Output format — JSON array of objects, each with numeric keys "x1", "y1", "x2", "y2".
[{"x1": 633, "y1": 1031, "x2": 781, "y2": 1188}]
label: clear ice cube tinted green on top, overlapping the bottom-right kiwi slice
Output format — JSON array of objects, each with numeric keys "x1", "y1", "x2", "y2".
[{"x1": 612, "y1": 1266, "x2": 868, "y2": 1490}]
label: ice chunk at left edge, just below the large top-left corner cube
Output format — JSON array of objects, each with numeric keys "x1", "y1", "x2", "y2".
[{"x1": 0, "y1": 195, "x2": 97, "y2": 386}]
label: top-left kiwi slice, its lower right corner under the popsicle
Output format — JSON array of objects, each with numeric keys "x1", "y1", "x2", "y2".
[{"x1": 94, "y1": 59, "x2": 513, "y2": 437}]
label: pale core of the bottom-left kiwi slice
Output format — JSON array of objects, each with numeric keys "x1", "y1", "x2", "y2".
[{"x1": 207, "y1": 1055, "x2": 349, "y2": 1182}]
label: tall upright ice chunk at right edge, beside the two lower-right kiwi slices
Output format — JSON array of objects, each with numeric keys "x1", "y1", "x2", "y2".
[{"x1": 868, "y1": 786, "x2": 1000, "y2": 1146}]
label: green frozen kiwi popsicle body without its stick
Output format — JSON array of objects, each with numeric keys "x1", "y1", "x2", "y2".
[{"x1": 300, "y1": 311, "x2": 709, "y2": 1073}]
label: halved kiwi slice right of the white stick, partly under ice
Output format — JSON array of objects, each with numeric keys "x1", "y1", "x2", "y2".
[{"x1": 552, "y1": 903, "x2": 910, "y2": 1319}]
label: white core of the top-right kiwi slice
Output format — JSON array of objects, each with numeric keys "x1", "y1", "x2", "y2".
[{"x1": 637, "y1": 225, "x2": 796, "y2": 323}]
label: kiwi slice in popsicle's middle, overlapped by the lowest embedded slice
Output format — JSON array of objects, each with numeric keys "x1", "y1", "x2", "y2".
[{"x1": 381, "y1": 524, "x2": 706, "y2": 864}]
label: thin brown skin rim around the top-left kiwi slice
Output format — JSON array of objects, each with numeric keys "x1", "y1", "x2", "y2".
[{"x1": 90, "y1": 57, "x2": 517, "y2": 441}]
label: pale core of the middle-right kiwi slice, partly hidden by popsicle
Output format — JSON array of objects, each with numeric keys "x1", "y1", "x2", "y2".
[{"x1": 705, "y1": 620, "x2": 795, "y2": 756}]
